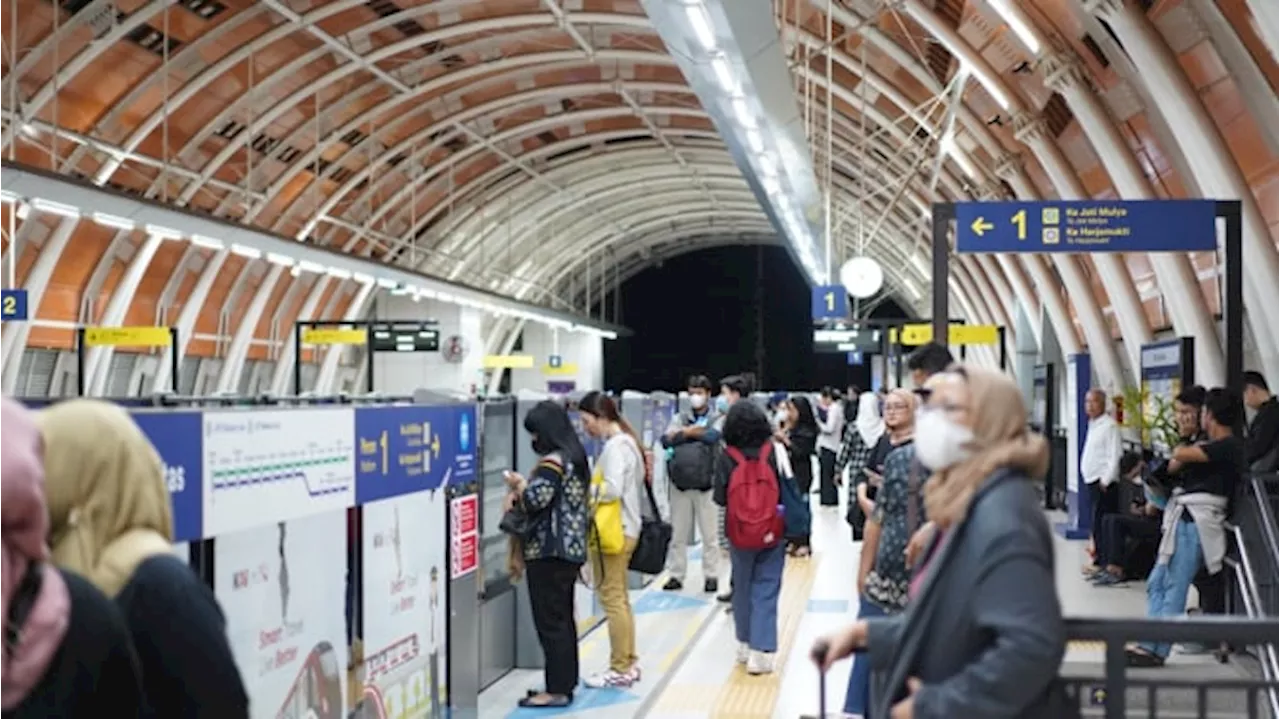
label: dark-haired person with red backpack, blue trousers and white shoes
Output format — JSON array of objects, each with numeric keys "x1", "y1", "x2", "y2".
[{"x1": 714, "y1": 402, "x2": 787, "y2": 674}]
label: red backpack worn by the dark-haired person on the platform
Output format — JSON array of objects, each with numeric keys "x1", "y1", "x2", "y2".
[{"x1": 724, "y1": 443, "x2": 785, "y2": 550}]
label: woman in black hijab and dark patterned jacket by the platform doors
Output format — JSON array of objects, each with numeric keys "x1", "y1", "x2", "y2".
[{"x1": 507, "y1": 400, "x2": 590, "y2": 709}]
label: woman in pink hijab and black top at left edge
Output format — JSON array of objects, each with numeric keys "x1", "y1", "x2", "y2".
[{"x1": 0, "y1": 399, "x2": 145, "y2": 719}]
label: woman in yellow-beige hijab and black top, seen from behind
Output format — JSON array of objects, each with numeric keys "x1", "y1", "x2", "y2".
[{"x1": 37, "y1": 399, "x2": 248, "y2": 719}]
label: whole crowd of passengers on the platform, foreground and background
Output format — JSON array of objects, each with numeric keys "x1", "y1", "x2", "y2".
[{"x1": 0, "y1": 344, "x2": 1280, "y2": 719}]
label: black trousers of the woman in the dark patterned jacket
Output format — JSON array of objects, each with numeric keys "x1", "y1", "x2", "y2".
[{"x1": 525, "y1": 559, "x2": 579, "y2": 697}]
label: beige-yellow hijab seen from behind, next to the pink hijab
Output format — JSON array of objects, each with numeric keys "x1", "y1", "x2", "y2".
[{"x1": 37, "y1": 399, "x2": 173, "y2": 596}]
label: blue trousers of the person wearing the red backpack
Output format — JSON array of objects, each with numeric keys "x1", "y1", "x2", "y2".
[{"x1": 728, "y1": 542, "x2": 787, "y2": 654}]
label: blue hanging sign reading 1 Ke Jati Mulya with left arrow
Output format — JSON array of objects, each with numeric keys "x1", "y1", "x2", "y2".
[{"x1": 955, "y1": 200, "x2": 1217, "y2": 252}]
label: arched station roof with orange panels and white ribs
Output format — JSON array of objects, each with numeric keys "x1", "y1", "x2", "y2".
[{"x1": 0, "y1": 0, "x2": 1280, "y2": 391}]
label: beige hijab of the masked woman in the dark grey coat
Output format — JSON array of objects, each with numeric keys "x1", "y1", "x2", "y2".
[{"x1": 924, "y1": 366, "x2": 1048, "y2": 527}]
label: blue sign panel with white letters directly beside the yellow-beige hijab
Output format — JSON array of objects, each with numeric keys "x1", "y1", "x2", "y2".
[{"x1": 133, "y1": 412, "x2": 205, "y2": 541}]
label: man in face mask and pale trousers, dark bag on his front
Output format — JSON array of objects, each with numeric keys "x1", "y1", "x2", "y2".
[{"x1": 662, "y1": 375, "x2": 721, "y2": 592}]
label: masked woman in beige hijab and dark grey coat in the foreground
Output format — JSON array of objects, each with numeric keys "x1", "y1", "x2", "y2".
[{"x1": 814, "y1": 367, "x2": 1078, "y2": 719}]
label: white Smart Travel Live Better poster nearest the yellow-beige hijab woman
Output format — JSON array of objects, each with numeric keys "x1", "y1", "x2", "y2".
[{"x1": 214, "y1": 510, "x2": 347, "y2": 719}]
